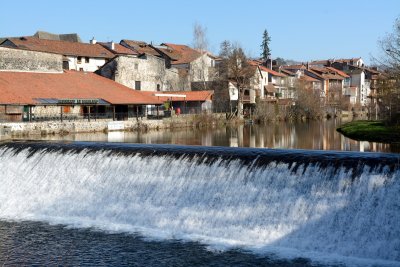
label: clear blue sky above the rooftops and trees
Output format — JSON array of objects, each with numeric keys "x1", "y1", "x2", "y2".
[{"x1": 0, "y1": 0, "x2": 400, "y2": 62}]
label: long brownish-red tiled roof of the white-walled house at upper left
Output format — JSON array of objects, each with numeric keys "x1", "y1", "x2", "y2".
[{"x1": 3, "y1": 37, "x2": 114, "y2": 58}]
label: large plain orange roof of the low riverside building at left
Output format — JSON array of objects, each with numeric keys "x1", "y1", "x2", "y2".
[{"x1": 0, "y1": 71, "x2": 161, "y2": 105}]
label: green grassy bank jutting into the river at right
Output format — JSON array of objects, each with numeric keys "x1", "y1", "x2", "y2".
[{"x1": 337, "y1": 121, "x2": 400, "y2": 143}]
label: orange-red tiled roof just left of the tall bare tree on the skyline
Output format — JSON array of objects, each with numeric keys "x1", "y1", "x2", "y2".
[{"x1": 159, "y1": 43, "x2": 203, "y2": 65}]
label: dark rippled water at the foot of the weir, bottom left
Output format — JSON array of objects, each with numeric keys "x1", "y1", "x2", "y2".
[{"x1": 0, "y1": 221, "x2": 332, "y2": 267}]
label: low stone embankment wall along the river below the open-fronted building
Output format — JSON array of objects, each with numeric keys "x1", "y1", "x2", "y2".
[{"x1": 0, "y1": 114, "x2": 226, "y2": 141}]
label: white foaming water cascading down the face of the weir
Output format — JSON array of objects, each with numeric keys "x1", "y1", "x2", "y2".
[{"x1": 0, "y1": 150, "x2": 400, "y2": 266}]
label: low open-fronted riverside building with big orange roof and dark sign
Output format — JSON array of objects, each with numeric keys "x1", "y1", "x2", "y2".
[{"x1": 0, "y1": 71, "x2": 162, "y2": 121}]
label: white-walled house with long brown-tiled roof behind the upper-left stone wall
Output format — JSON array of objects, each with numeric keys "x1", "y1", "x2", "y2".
[{"x1": 0, "y1": 37, "x2": 114, "y2": 72}]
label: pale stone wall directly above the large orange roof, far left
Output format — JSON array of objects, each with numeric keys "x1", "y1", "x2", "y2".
[{"x1": 0, "y1": 47, "x2": 63, "y2": 73}]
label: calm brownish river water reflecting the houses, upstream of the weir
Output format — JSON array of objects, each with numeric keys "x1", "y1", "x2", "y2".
[{"x1": 18, "y1": 120, "x2": 400, "y2": 153}]
